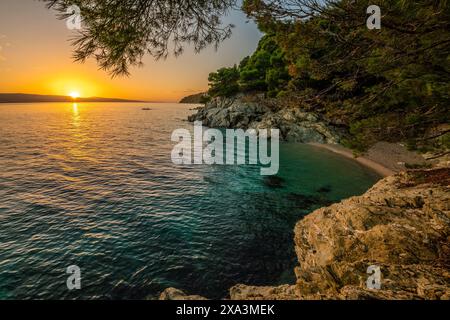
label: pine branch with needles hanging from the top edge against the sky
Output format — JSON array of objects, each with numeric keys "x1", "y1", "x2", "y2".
[{"x1": 41, "y1": 0, "x2": 236, "y2": 76}]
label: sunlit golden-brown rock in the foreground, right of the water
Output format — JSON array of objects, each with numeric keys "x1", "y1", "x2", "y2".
[{"x1": 160, "y1": 168, "x2": 450, "y2": 300}]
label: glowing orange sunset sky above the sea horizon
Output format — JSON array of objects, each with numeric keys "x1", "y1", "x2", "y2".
[{"x1": 0, "y1": 0, "x2": 260, "y2": 101}]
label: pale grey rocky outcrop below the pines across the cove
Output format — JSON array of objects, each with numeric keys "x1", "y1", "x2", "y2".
[{"x1": 189, "y1": 96, "x2": 340, "y2": 144}]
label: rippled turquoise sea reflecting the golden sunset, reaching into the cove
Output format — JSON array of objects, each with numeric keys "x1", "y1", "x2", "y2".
[{"x1": 0, "y1": 104, "x2": 379, "y2": 299}]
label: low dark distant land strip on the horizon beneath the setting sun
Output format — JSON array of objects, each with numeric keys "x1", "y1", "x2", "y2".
[{"x1": 0, "y1": 93, "x2": 147, "y2": 103}]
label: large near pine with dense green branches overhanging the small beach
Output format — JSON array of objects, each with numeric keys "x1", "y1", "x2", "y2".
[{"x1": 241, "y1": 0, "x2": 450, "y2": 151}]
